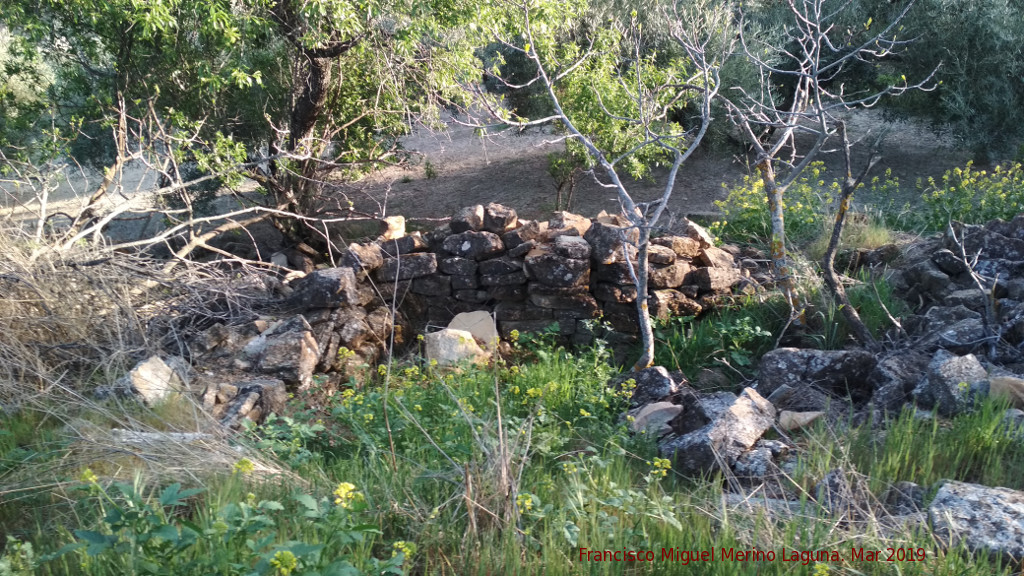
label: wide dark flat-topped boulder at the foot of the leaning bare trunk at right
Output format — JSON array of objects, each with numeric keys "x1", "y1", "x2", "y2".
[{"x1": 758, "y1": 347, "x2": 877, "y2": 401}]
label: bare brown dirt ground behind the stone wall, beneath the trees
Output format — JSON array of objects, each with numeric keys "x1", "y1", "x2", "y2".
[{"x1": 341, "y1": 110, "x2": 969, "y2": 223}]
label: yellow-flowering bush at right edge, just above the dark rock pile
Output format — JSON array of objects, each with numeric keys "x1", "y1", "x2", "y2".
[{"x1": 919, "y1": 162, "x2": 1024, "y2": 231}]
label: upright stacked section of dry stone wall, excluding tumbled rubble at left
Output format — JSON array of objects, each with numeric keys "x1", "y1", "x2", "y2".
[{"x1": 299, "y1": 204, "x2": 756, "y2": 362}]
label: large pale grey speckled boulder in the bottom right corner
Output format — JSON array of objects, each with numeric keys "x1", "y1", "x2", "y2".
[{"x1": 928, "y1": 481, "x2": 1024, "y2": 562}]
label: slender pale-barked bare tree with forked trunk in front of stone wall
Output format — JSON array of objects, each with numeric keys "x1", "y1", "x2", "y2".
[{"x1": 483, "y1": 2, "x2": 732, "y2": 369}]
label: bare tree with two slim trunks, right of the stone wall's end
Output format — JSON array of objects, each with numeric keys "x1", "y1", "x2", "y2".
[{"x1": 726, "y1": 0, "x2": 932, "y2": 343}]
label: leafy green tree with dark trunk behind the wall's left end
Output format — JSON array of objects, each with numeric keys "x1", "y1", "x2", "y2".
[{"x1": 3, "y1": 0, "x2": 478, "y2": 251}]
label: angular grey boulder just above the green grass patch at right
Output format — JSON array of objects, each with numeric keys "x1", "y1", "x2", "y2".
[{"x1": 912, "y1": 349, "x2": 988, "y2": 417}]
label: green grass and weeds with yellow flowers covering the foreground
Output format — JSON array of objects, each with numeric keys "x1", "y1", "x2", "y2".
[{"x1": 0, "y1": 332, "x2": 1024, "y2": 576}]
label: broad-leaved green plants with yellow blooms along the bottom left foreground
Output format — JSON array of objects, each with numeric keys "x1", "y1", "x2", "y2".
[{"x1": 40, "y1": 470, "x2": 414, "y2": 576}]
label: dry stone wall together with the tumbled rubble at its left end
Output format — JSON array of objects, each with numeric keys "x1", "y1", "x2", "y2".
[{"x1": 178, "y1": 204, "x2": 758, "y2": 422}]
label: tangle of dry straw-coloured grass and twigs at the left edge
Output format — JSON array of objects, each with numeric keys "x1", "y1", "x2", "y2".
[{"x1": 0, "y1": 224, "x2": 303, "y2": 500}]
